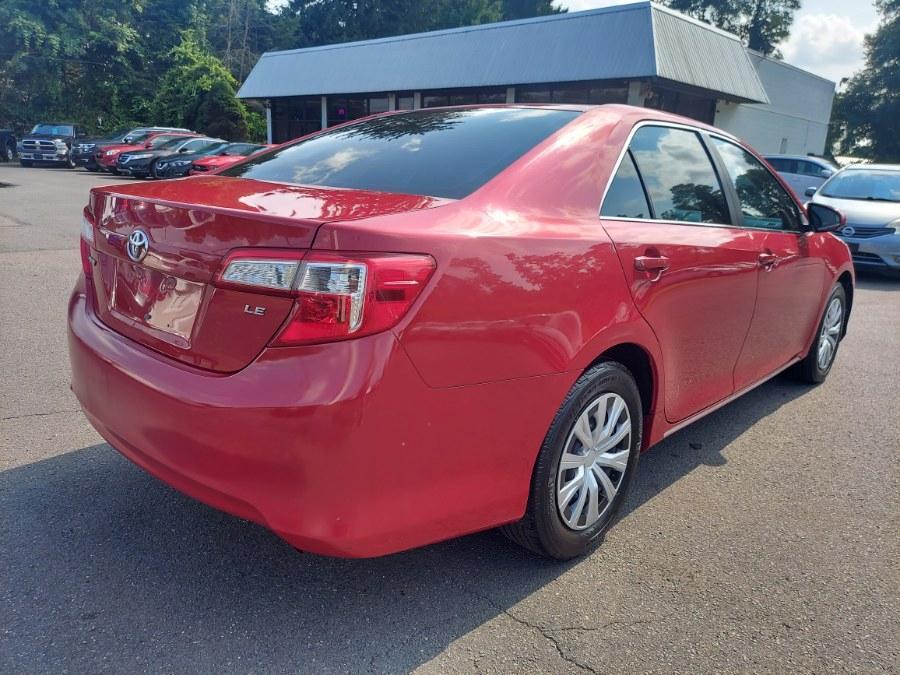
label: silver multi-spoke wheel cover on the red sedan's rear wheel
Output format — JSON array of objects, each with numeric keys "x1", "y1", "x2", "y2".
[{"x1": 556, "y1": 393, "x2": 631, "y2": 530}]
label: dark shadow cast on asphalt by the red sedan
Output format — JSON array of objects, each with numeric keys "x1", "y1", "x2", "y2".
[{"x1": 0, "y1": 378, "x2": 808, "y2": 672}]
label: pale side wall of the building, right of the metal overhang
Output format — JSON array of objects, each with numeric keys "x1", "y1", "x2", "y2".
[{"x1": 716, "y1": 52, "x2": 834, "y2": 155}]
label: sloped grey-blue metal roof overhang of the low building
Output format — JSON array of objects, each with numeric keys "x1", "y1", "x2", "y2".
[{"x1": 238, "y1": 1, "x2": 768, "y2": 103}]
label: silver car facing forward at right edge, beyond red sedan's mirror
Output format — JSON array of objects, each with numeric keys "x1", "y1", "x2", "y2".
[{"x1": 806, "y1": 164, "x2": 900, "y2": 275}]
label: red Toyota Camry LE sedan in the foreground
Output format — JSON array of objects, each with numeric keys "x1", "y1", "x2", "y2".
[{"x1": 68, "y1": 106, "x2": 854, "y2": 559}]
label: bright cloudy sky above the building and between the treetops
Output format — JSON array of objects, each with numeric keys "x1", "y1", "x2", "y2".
[{"x1": 557, "y1": 0, "x2": 878, "y2": 83}]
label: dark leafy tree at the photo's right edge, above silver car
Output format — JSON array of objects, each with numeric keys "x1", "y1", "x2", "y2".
[{"x1": 830, "y1": 0, "x2": 900, "y2": 162}]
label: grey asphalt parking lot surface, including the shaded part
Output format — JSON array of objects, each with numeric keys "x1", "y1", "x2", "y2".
[{"x1": 0, "y1": 164, "x2": 900, "y2": 673}]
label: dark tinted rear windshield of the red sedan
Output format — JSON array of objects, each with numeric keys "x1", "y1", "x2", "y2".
[{"x1": 221, "y1": 108, "x2": 580, "y2": 199}]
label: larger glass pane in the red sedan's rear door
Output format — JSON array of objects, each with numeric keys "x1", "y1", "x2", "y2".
[{"x1": 630, "y1": 127, "x2": 731, "y2": 225}]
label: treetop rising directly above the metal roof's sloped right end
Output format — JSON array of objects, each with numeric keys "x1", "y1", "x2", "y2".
[{"x1": 665, "y1": 0, "x2": 800, "y2": 57}]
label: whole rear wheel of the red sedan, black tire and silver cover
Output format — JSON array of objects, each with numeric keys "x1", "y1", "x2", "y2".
[{"x1": 502, "y1": 361, "x2": 643, "y2": 560}]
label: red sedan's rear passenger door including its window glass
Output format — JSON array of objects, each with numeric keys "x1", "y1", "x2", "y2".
[{"x1": 601, "y1": 123, "x2": 764, "y2": 422}]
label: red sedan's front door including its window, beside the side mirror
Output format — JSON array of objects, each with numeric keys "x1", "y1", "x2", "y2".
[{"x1": 711, "y1": 137, "x2": 830, "y2": 389}]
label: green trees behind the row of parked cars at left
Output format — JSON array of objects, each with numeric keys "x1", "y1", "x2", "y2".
[{"x1": 0, "y1": 0, "x2": 556, "y2": 140}]
